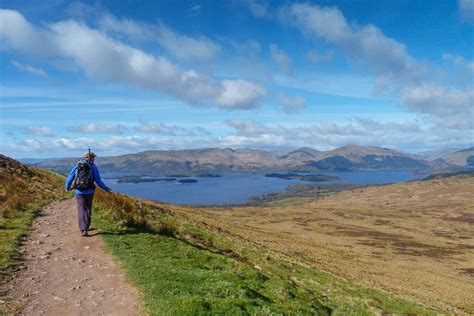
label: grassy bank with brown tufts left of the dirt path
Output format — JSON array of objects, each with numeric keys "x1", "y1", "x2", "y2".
[{"x1": 0, "y1": 155, "x2": 65, "y2": 282}]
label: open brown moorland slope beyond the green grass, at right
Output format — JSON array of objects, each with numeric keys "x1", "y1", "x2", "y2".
[{"x1": 167, "y1": 175, "x2": 474, "y2": 314}]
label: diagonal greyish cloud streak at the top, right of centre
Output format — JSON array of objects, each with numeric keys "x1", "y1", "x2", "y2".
[{"x1": 283, "y1": 3, "x2": 425, "y2": 92}]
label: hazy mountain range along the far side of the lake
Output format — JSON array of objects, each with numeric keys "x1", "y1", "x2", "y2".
[{"x1": 38, "y1": 145, "x2": 436, "y2": 175}]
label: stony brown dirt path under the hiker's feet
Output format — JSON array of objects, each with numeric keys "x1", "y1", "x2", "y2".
[{"x1": 2, "y1": 199, "x2": 143, "y2": 315}]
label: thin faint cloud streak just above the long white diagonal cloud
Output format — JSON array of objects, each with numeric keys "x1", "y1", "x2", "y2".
[{"x1": 99, "y1": 14, "x2": 221, "y2": 61}]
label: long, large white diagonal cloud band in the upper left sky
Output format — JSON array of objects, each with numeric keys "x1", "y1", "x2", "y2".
[{"x1": 0, "y1": 10, "x2": 266, "y2": 110}]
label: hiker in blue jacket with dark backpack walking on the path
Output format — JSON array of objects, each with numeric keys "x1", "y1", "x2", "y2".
[{"x1": 66, "y1": 149, "x2": 112, "y2": 237}]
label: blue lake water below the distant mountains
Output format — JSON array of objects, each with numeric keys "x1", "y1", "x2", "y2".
[{"x1": 103, "y1": 171, "x2": 424, "y2": 205}]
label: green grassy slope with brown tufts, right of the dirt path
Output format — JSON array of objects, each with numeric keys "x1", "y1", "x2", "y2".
[{"x1": 94, "y1": 193, "x2": 439, "y2": 315}]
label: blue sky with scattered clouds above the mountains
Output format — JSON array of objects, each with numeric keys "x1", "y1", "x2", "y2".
[{"x1": 0, "y1": 0, "x2": 474, "y2": 158}]
